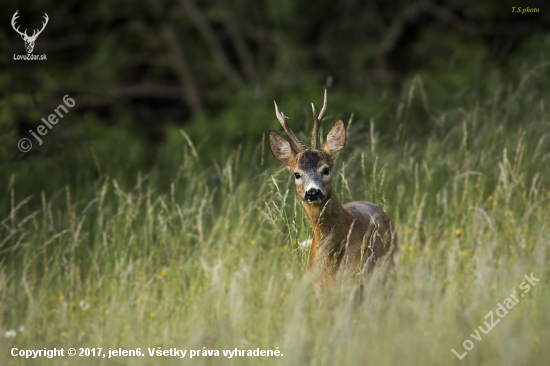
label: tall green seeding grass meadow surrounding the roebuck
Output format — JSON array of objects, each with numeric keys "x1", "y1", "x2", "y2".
[{"x1": 0, "y1": 69, "x2": 550, "y2": 365}]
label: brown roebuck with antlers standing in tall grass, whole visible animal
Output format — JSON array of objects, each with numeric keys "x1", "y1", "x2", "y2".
[{"x1": 269, "y1": 89, "x2": 397, "y2": 285}]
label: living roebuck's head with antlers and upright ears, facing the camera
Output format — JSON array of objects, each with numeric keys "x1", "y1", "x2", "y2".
[{"x1": 269, "y1": 90, "x2": 346, "y2": 205}]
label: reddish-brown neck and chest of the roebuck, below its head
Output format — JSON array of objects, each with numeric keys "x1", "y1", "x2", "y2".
[{"x1": 305, "y1": 192, "x2": 353, "y2": 268}]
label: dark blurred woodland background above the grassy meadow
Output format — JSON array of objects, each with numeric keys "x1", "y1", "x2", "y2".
[{"x1": 0, "y1": 0, "x2": 550, "y2": 197}]
